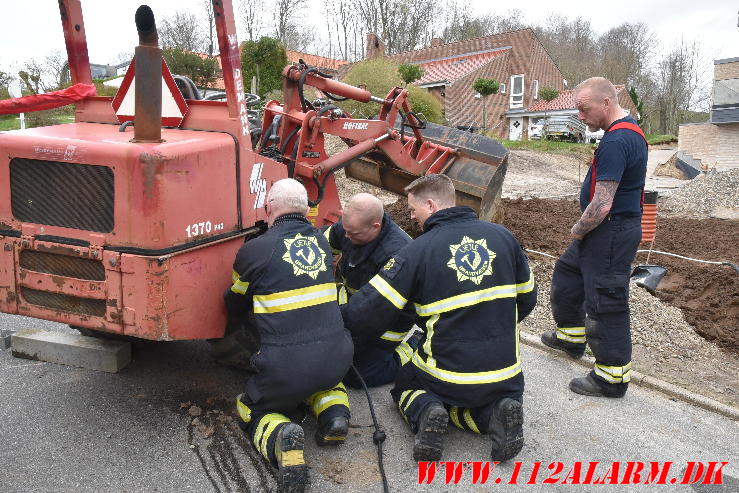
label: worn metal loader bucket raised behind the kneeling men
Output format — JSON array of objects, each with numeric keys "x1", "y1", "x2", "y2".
[{"x1": 346, "y1": 122, "x2": 508, "y2": 222}]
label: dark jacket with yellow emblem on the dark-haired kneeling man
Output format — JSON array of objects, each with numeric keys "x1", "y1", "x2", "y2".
[{"x1": 342, "y1": 207, "x2": 536, "y2": 407}]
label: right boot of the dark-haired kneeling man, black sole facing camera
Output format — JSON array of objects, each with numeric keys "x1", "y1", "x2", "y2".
[{"x1": 488, "y1": 397, "x2": 523, "y2": 462}]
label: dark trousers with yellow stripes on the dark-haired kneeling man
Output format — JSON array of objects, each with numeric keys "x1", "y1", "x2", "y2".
[{"x1": 390, "y1": 363, "x2": 523, "y2": 435}]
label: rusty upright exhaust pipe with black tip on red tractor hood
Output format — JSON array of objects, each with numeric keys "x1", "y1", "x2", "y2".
[{"x1": 133, "y1": 5, "x2": 162, "y2": 142}]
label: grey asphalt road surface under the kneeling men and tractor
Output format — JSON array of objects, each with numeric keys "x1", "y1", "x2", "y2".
[{"x1": 0, "y1": 314, "x2": 739, "y2": 493}]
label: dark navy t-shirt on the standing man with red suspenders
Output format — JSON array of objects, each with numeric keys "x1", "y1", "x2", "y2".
[{"x1": 580, "y1": 116, "x2": 647, "y2": 216}]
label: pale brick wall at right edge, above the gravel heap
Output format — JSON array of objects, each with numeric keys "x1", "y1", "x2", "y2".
[{"x1": 678, "y1": 123, "x2": 739, "y2": 168}]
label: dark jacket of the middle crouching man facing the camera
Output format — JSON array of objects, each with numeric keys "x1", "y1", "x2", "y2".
[{"x1": 324, "y1": 213, "x2": 415, "y2": 348}]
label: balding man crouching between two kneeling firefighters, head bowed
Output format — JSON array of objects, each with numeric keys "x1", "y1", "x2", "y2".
[{"x1": 324, "y1": 193, "x2": 415, "y2": 387}]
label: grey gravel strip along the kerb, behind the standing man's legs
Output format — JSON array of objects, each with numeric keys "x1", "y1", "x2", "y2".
[{"x1": 521, "y1": 253, "x2": 739, "y2": 406}]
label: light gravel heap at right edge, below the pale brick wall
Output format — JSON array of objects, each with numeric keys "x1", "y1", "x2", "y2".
[{"x1": 660, "y1": 169, "x2": 739, "y2": 217}]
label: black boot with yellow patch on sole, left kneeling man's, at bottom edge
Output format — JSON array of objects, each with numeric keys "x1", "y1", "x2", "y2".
[{"x1": 275, "y1": 423, "x2": 308, "y2": 493}]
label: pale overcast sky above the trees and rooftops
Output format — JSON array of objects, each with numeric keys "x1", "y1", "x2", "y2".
[{"x1": 0, "y1": 0, "x2": 739, "y2": 73}]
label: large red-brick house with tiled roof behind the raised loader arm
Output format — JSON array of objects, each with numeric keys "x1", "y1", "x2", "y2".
[{"x1": 367, "y1": 28, "x2": 565, "y2": 140}]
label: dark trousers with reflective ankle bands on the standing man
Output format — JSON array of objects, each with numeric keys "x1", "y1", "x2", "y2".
[{"x1": 551, "y1": 216, "x2": 641, "y2": 394}]
